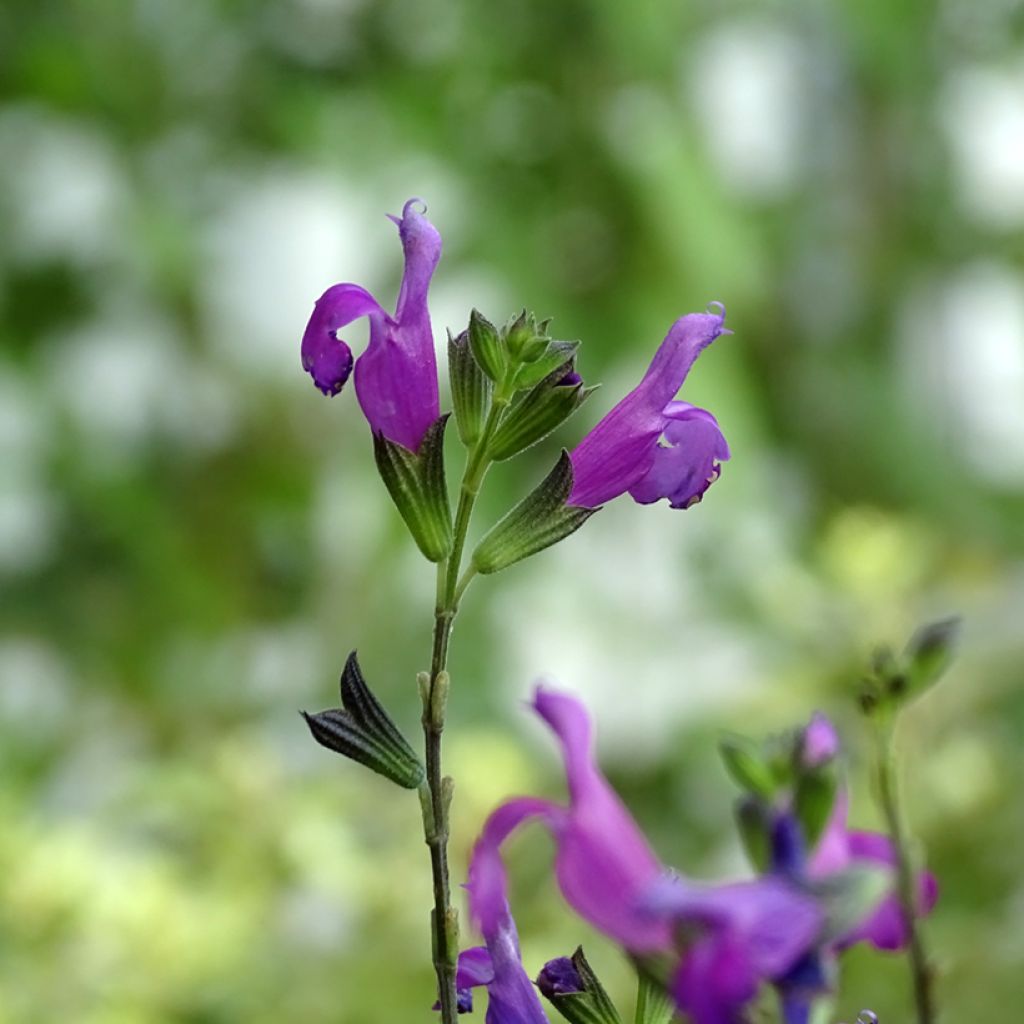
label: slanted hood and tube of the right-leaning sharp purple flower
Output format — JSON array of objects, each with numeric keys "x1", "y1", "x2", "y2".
[{"x1": 568, "y1": 313, "x2": 728, "y2": 508}]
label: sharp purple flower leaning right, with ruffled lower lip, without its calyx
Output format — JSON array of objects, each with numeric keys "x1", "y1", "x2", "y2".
[{"x1": 568, "y1": 302, "x2": 730, "y2": 509}]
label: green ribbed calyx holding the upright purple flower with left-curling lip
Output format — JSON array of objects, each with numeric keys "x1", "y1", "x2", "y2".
[{"x1": 374, "y1": 414, "x2": 452, "y2": 562}]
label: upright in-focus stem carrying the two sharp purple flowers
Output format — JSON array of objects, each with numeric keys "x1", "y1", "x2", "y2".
[{"x1": 423, "y1": 396, "x2": 508, "y2": 1024}]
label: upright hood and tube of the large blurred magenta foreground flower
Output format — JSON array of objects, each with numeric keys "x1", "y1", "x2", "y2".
[{"x1": 534, "y1": 687, "x2": 671, "y2": 952}]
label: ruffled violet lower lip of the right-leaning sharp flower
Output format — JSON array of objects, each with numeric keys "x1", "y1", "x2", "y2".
[{"x1": 630, "y1": 401, "x2": 729, "y2": 509}]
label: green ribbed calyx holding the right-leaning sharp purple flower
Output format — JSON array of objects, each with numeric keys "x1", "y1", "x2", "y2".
[{"x1": 472, "y1": 450, "x2": 597, "y2": 574}]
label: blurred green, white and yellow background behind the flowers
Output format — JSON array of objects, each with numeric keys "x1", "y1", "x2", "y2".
[{"x1": 0, "y1": 0, "x2": 1024, "y2": 1024}]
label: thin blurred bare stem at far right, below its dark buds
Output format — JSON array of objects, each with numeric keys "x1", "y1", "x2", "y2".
[{"x1": 878, "y1": 724, "x2": 936, "y2": 1024}]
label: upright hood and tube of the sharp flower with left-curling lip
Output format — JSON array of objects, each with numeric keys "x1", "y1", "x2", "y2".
[{"x1": 355, "y1": 200, "x2": 441, "y2": 452}]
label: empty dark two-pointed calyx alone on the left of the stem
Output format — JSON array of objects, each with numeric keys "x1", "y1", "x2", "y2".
[{"x1": 301, "y1": 650, "x2": 425, "y2": 790}]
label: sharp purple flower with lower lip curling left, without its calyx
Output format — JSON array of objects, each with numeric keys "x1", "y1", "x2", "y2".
[{"x1": 302, "y1": 200, "x2": 441, "y2": 452}]
